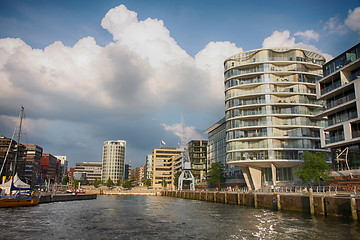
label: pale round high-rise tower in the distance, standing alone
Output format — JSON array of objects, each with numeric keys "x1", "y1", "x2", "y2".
[{"x1": 101, "y1": 140, "x2": 126, "y2": 183}]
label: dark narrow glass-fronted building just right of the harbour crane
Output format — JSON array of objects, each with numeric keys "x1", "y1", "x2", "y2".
[{"x1": 188, "y1": 140, "x2": 208, "y2": 184}]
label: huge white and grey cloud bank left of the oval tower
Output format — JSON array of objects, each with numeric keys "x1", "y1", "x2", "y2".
[{"x1": 0, "y1": 5, "x2": 242, "y2": 166}]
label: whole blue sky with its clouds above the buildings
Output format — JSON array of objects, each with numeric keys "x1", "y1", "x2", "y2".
[{"x1": 0, "y1": 0, "x2": 360, "y2": 168}]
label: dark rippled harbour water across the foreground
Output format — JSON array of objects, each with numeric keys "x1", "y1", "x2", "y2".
[{"x1": 0, "y1": 196, "x2": 360, "y2": 240}]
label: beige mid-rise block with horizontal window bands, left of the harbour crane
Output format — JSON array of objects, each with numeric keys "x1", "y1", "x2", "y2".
[{"x1": 151, "y1": 147, "x2": 183, "y2": 189}]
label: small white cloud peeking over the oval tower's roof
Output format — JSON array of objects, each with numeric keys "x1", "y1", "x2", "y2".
[{"x1": 263, "y1": 30, "x2": 333, "y2": 61}]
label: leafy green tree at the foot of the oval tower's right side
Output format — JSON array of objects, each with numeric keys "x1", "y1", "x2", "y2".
[{"x1": 295, "y1": 151, "x2": 329, "y2": 186}]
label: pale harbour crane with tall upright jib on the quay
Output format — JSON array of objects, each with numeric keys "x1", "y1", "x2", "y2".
[{"x1": 178, "y1": 113, "x2": 195, "y2": 191}]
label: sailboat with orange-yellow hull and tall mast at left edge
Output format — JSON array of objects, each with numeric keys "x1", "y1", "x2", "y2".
[{"x1": 0, "y1": 106, "x2": 40, "y2": 207}]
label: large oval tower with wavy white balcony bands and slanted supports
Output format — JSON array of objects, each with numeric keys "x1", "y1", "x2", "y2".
[{"x1": 224, "y1": 48, "x2": 327, "y2": 189}]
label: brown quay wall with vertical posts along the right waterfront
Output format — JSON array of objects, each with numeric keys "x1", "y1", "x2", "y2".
[{"x1": 162, "y1": 191, "x2": 360, "y2": 220}]
